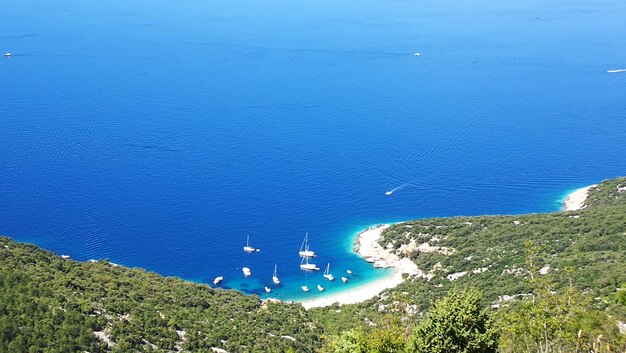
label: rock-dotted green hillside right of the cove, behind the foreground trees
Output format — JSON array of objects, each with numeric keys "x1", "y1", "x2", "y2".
[{"x1": 312, "y1": 178, "x2": 626, "y2": 333}]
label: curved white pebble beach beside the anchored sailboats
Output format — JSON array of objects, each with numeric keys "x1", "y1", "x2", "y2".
[{"x1": 301, "y1": 224, "x2": 419, "y2": 309}]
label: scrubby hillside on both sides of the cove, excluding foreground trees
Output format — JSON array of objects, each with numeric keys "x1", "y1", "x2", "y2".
[{"x1": 0, "y1": 178, "x2": 626, "y2": 353}]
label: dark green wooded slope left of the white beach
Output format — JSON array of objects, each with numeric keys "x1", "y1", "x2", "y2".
[{"x1": 0, "y1": 237, "x2": 320, "y2": 353}]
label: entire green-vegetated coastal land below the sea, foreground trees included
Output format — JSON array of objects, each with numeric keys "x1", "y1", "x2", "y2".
[{"x1": 0, "y1": 178, "x2": 626, "y2": 353}]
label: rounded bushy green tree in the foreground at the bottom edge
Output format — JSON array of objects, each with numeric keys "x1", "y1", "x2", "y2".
[{"x1": 407, "y1": 290, "x2": 498, "y2": 353}]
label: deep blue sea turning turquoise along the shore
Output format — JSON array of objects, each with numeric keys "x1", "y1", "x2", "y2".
[{"x1": 0, "y1": 0, "x2": 626, "y2": 299}]
